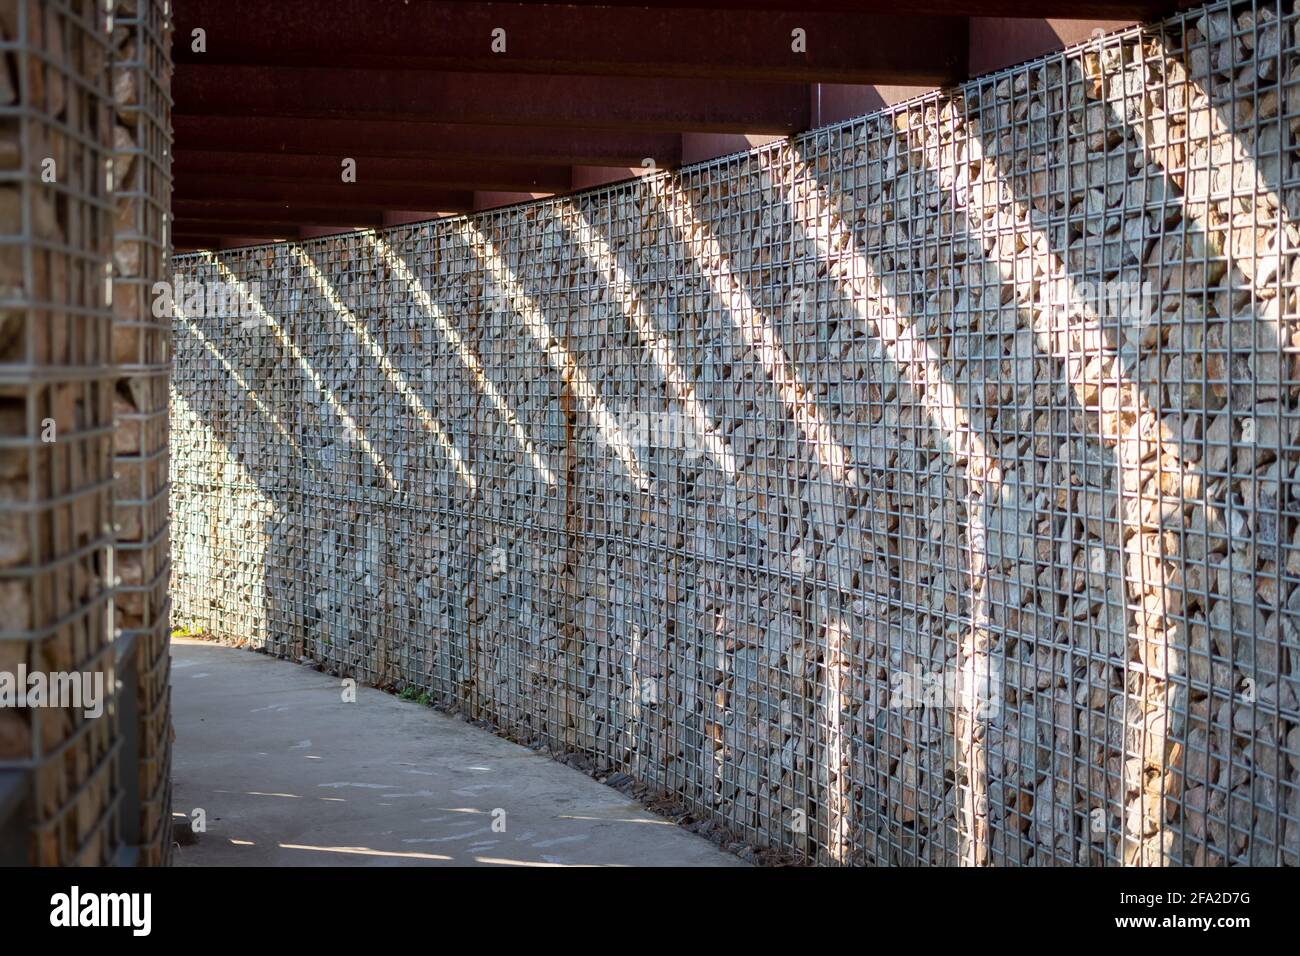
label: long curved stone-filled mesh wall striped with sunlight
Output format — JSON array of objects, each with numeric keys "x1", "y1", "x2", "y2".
[{"x1": 172, "y1": 3, "x2": 1300, "y2": 865}]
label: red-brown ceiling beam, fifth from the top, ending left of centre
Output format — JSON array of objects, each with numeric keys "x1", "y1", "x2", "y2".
[{"x1": 172, "y1": 148, "x2": 572, "y2": 193}]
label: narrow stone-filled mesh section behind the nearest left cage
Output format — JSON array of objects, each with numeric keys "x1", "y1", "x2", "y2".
[{"x1": 112, "y1": 0, "x2": 172, "y2": 865}]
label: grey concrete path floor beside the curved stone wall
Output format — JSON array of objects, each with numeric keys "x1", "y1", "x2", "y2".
[{"x1": 172, "y1": 640, "x2": 745, "y2": 866}]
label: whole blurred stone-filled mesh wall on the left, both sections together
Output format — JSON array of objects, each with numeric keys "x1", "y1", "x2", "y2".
[{"x1": 0, "y1": 0, "x2": 172, "y2": 865}]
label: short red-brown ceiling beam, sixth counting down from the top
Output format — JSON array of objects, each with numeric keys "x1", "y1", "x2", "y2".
[{"x1": 173, "y1": 173, "x2": 473, "y2": 209}]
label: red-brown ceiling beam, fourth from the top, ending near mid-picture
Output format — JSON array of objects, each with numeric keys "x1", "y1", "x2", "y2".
[{"x1": 172, "y1": 113, "x2": 681, "y2": 168}]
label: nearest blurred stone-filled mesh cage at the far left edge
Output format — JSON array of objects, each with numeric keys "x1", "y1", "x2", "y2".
[{"x1": 0, "y1": 0, "x2": 121, "y2": 865}]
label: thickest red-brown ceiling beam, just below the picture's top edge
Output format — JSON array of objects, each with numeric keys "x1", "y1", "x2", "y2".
[{"x1": 176, "y1": 0, "x2": 967, "y2": 85}]
